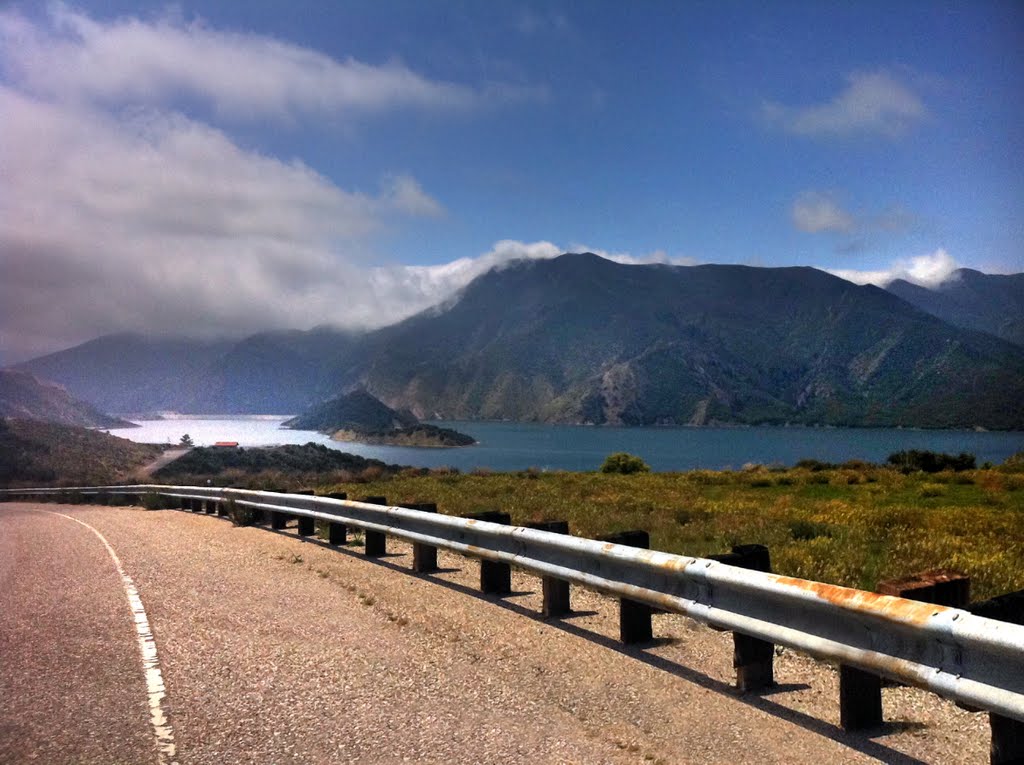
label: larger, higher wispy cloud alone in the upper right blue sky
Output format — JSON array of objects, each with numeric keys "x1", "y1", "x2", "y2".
[{"x1": 762, "y1": 71, "x2": 927, "y2": 137}]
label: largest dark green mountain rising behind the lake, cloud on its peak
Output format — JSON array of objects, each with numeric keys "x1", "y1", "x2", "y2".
[{"x1": 337, "y1": 254, "x2": 1024, "y2": 428}]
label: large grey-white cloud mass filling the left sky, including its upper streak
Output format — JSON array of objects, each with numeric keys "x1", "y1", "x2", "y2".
[{"x1": 0, "y1": 5, "x2": 553, "y2": 363}]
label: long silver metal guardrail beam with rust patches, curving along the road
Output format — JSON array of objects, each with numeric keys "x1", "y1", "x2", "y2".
[{"x1": 4, "y1": 484, "x2": 1024, "y2": 721}]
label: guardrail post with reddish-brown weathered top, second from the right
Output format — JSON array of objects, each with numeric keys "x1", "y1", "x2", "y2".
[{"x1": 839, "y1": 568, "x2": 971, "y2": 730}]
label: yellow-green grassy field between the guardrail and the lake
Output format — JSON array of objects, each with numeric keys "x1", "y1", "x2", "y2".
[{"x1": 317, "y1": 465, "x2": 1024, "y2": 599}]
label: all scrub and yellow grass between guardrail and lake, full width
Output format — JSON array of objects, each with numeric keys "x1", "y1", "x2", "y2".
[{"x1": 8, "y1": 430, "x2": 1024, "y2": 599}]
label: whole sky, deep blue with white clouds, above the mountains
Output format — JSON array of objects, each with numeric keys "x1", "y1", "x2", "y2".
[{"x1": 0, "y1": 0, "x2": 1024, "y2": 360}]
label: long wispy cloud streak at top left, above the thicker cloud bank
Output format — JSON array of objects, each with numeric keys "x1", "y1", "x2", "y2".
[{"x1": 0, "y1": 4, "x2": 541, "y2": 119}]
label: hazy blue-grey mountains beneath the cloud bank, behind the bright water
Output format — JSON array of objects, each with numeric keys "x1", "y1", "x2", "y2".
[{"x1": 16, "y1": 328, "x2": 356, "y2": 414}]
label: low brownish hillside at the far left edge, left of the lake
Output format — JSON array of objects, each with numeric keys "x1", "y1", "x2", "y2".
[{"x1": 0, "y1": 369, "x2": 132, "y2": 428}]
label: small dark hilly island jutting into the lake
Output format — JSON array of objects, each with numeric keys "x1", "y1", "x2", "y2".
[{"x1": 283, "y1": 389, "x2": 476, "y2": 449}]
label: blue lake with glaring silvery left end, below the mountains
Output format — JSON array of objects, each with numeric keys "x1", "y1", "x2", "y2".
[{"x1": 110, "y1": 416, "x2": 1024, "y2": 471}]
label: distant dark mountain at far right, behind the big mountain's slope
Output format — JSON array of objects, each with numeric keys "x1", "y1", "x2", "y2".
[{"x1": 887, "y1": 268, "x2": 1024, "y2": 345}]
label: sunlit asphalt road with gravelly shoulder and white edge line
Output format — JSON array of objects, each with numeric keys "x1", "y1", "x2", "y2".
[{"x1": 0, "y1": 504, "x2": 988, "y2": 765}]
